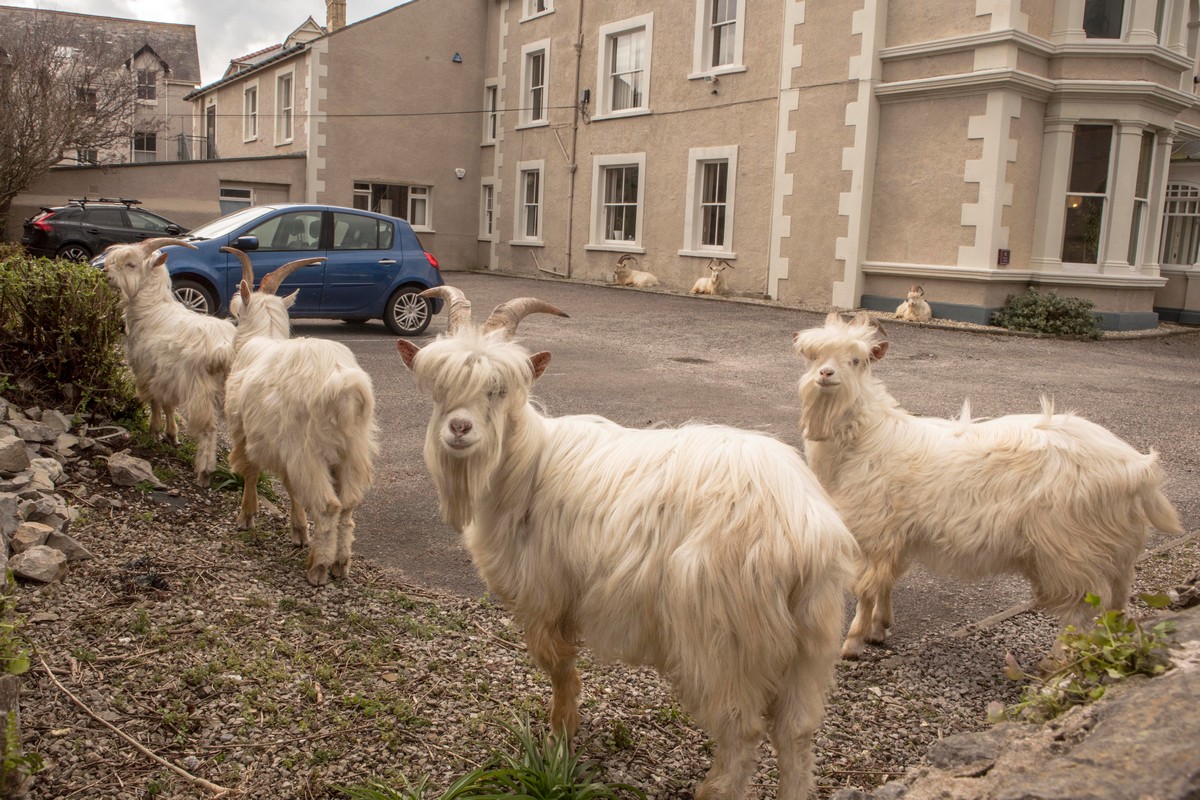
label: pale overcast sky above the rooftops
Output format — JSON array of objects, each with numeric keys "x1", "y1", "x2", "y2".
[{"x1": 0, "y1": 0, "x2": 407, "y2": 84}]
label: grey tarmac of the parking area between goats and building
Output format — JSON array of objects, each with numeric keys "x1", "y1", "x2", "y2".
[{"x1": 294, "y1": 272, "x2": 1200, "y2": 652}]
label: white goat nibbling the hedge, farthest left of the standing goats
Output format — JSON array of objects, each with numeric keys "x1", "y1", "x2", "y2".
[{"x1": 103, "y1": 239, "x2": 234, "y2": 486}]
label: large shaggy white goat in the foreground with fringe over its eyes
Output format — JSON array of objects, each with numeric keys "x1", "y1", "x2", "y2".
[{"x1": 396, "y1": 287, "x2": 856, "y2": 800}]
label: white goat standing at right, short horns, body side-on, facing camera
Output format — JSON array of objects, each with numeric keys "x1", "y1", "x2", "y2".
[{"x1": 794, "y1": 313, "x2": 1182, "y2": 658}]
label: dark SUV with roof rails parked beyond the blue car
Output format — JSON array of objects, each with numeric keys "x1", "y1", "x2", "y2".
[{"x1": 20, "y1": 198, "x2": 187, "y2": 261}]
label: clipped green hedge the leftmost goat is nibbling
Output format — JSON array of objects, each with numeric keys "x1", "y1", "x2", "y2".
[{"x1": 0, "y1": 246, "x2": 139, "y2": 417}]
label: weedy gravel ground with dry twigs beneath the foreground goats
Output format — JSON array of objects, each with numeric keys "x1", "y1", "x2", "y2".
[{"x1": 18, "y1": 443, "x2": 1198, "y2": 800}]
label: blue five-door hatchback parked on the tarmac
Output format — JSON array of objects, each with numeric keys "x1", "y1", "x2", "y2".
[{"x1": 102, "y1": 204, "x2": 444, "y2": 336}]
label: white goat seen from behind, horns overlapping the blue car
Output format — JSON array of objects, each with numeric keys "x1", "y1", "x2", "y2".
[{"x1": 221, "y1": 247, "x2": 379, "y2": 587}]
